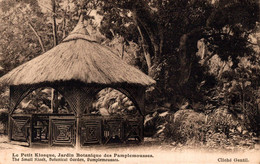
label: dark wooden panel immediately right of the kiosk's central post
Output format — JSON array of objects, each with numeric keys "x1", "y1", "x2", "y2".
[{"x1": 80, "y1": 118, "x2": 102, "y2": 146}]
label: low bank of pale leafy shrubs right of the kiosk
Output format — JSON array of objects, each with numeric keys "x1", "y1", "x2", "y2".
[{"x1": 160, "y1": 108, "x2": 255, "y2": 149}]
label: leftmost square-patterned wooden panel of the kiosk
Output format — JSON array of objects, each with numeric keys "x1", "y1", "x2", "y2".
[{"x1": 11, "y1": 117, "x2": 30, "y2": 141}]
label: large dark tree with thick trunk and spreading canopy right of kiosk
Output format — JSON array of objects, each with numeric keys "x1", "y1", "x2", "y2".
[{"x1": 97, "y1": 0, "x2": 259, "y2": 106}]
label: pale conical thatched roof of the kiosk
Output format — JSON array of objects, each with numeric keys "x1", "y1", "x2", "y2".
[{"x1": 0, "y1": 16, "x2": 155, "y2": 86}]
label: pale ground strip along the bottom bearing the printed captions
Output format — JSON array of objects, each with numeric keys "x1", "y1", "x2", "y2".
[{"x1": 0, "y1": 136, "x2": 260, "y2": 164}]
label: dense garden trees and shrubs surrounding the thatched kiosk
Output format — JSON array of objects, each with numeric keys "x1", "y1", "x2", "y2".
[{"x1": 0, "y1": 0, "x2": 260, "y2": 148}]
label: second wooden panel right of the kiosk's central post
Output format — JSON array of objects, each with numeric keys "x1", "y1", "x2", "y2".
[{"x1": 104, "y1": 118, "x2": 123, "y2": 144}]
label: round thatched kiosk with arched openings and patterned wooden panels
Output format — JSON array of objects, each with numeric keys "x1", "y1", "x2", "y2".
[{"x1": 0, "y1": 14, "x2": 155, "y2": 146}]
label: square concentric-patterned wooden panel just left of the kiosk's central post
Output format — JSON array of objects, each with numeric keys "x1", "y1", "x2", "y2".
[{"x1": 50, "y1": 117, "x2": 76, "y2": 146}]
